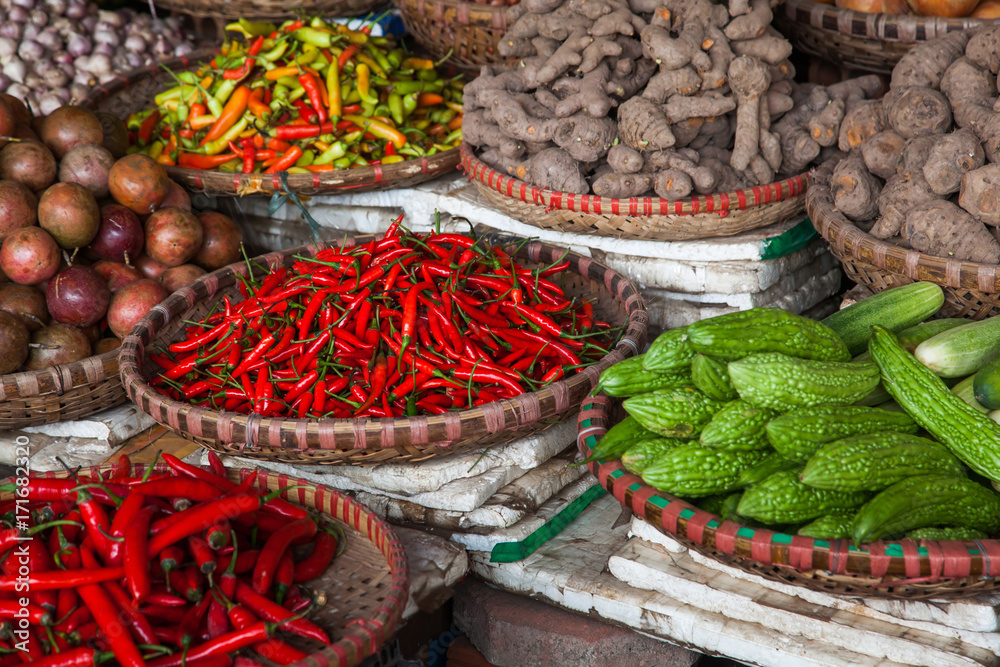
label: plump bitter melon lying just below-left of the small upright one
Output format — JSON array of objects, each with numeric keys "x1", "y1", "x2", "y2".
[{"x1": 623, "y1": 387, "x2": 725, "y2": 440}]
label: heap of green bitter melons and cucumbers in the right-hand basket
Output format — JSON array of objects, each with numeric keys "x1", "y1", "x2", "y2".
[{"x1": 589, "y1": 283, "x2": 1000, "y2": 543}]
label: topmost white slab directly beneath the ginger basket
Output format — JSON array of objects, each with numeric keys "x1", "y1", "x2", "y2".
[{"x1": 218, "y1": 174, "x2": 802, "y2": 261}]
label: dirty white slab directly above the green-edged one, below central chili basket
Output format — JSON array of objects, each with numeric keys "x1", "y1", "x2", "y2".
[{"x1": 357, "y1": 445, "x2": 587, "y2": 530}]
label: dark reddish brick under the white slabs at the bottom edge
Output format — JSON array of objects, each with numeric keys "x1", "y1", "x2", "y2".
[{"x1": 455, "y1": 578, "x2": 700, "y2": 667}]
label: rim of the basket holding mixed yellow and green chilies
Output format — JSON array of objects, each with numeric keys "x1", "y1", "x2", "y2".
[{"x1": 80, "y1": 49, "x2": 461, "y2": 196}]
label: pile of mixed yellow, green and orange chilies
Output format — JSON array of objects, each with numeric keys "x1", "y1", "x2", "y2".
[{"x1": 128, "y1": 17, "x2": 463, "y2": 174}]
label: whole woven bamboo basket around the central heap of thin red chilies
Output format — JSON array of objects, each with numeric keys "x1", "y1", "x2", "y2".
[{"x1": 119, "y1": 232, "x2": 649, "y2": 465}]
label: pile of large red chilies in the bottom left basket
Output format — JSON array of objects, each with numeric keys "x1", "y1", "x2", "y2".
[{"x1": 0, "y1": 454, "x2": 345, "y2": 667}]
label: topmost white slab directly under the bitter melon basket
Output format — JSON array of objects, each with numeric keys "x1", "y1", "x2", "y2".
[{"x1": 630, "y1": 517, "x2": 1000, "y2": 636}]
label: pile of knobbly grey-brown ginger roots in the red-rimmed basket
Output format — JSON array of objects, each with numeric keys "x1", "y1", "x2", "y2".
[{"x1": 463, "y1": 0, "x2": 881, "y2": 200}]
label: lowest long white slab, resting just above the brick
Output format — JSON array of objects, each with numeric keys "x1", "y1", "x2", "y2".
[{"x1": 470, "y1": 496, "x2": 998, "y2": 667}]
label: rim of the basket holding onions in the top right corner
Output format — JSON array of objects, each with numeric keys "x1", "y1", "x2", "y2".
[{"x1": 781, "y1": 0, "x2": 996, "y2": 43}]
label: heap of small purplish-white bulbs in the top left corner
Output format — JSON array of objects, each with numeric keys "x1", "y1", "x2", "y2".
[{"x1": 0, "y1": 0, "x2": 192, "y2": 115}]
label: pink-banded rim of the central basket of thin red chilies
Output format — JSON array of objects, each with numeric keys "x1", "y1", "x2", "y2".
[{"x1": 118, "y1": 235, "x2": 649, "y2": 451}]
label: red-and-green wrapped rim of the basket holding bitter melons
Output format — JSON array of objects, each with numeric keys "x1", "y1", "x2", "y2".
[{"x1": 577, "y1": 392, "x2": 1000, "y2": 596}]
